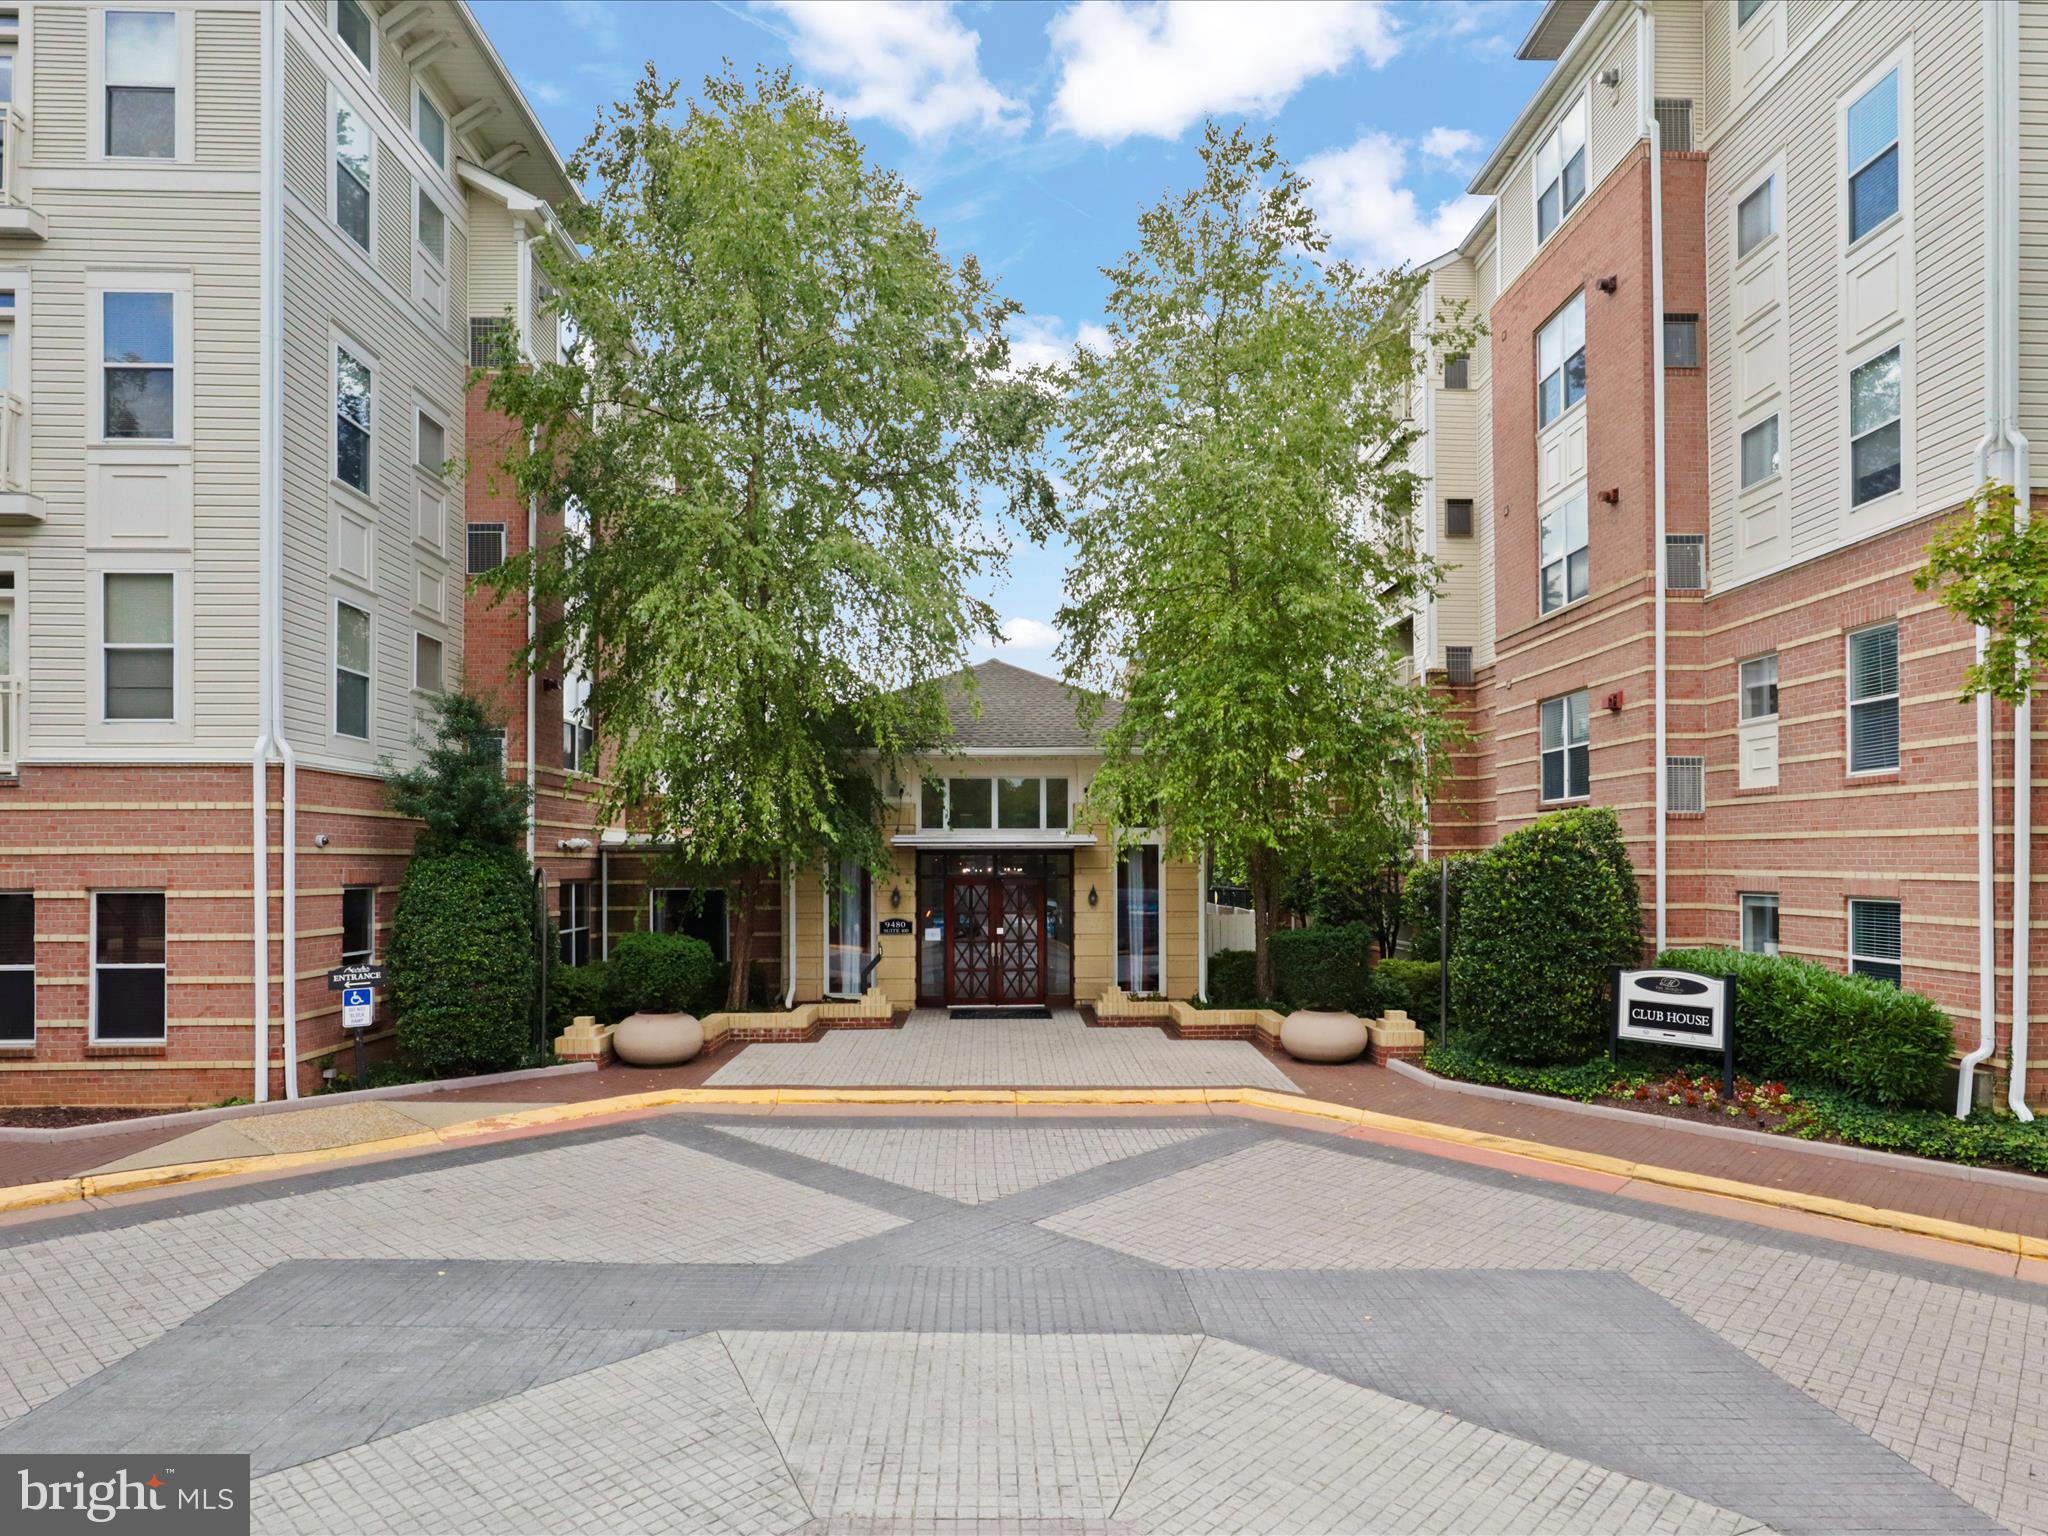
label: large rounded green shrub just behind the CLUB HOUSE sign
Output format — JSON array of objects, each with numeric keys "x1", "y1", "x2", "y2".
[{"x1": 1450, "y1": 807, "x2": 1642, "y2": 1065}]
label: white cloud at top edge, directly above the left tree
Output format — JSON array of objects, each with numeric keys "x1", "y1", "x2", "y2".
[{"x1": 762, "y1": 0, "x2": 1030, "y2": 139}]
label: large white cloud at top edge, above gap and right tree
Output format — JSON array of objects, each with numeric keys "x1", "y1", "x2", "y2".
[{"x1": 1047, "y1": 0, "x2": 1401, "y2": 143}]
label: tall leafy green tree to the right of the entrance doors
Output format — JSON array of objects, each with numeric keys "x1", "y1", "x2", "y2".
[{"x1": 1059, "y1": 123, "x2": 1470, "y2": 997}]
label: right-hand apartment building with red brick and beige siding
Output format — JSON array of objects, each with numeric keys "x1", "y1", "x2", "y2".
[{"x1": 1415, "y1": 0, "x2": 2048, "y2": 1102}]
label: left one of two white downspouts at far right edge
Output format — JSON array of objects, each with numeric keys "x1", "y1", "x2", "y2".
[{"x1": 1956, "y1": 4, "x2": 2017, "y2": 1120}]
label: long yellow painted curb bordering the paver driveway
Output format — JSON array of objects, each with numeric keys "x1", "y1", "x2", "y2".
[{"x1": 0, "y1": 1087, "x2": 2048, "y2": 1260}]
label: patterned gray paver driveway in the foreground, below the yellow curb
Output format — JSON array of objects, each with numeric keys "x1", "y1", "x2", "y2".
[{"x1": 0, "y1": 1114, "x2": 2048, "y2": 1532}]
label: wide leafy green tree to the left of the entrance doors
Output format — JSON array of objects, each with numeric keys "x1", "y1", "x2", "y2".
[{"x1": 489, "y1": 68, "x2": 1053, "y2": 1008}]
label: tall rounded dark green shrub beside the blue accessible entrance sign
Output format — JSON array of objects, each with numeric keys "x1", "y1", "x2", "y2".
[{"x1": 391, "y1": 846, "x2": 539, "y2": 1077}]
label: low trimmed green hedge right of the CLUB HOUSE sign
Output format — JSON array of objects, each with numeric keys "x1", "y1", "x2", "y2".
[{"x1": 1657, "y1": 950, "x2": 1956, "y2": 1108}]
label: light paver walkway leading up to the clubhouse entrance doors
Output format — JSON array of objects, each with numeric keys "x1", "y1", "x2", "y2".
[{"x1": 705, "y1": 1008, "x2": 1300, "y2": 1094}]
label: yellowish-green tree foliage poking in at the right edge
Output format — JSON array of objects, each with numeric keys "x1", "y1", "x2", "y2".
[{"x1": 1913, "y1": 481, "x2": 2048, "y2": 707}]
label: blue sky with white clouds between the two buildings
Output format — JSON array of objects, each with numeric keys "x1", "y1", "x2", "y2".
[{"x1": 473, "y1": 0, "x2": 1548, "y2": 670}]
